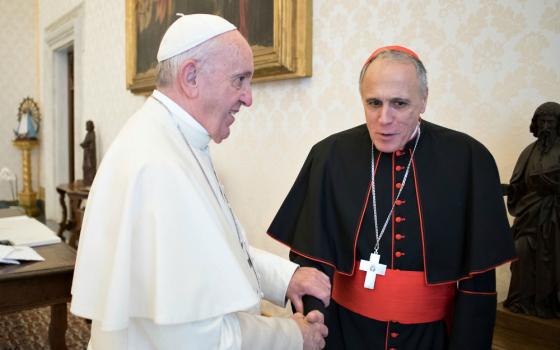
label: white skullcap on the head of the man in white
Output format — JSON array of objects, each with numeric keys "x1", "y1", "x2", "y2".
[{"x1": 157, "y1": 13, "x2": 237, "y2": 62}]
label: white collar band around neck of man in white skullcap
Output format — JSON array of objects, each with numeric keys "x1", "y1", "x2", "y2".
[{"x1": 152, "y1": 90, "x2": 210, "y2": 150}]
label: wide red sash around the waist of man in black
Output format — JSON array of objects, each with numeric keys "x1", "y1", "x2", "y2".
[{"x1": 332, "y1": 262, "x2": 457, "y2": 324}]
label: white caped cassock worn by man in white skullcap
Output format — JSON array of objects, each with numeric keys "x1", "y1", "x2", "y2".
[{"x1": 70, "y1": 91, "x2": 303, "y2": 350}]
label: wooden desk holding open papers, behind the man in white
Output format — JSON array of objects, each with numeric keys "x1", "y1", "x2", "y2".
[{"x1": 0, "y1": 243, "x2": 76, "y2": 350}]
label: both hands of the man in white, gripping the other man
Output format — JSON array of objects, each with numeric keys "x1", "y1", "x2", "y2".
[{"x1": 286, "y1": 267, "x2": 331, "y2": 350}]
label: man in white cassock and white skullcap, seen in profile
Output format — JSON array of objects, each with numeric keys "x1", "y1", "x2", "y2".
[{"x1": 71, "y1": 15, "x2": 330, "y2": 350}]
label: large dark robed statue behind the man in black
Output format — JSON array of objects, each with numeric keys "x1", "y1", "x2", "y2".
[{"x1": 504, "y1": 102, "x2": 560, "y2": 318}]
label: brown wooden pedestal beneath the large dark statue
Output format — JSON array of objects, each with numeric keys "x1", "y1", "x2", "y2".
[{"x1": 492, "y1": 303, "x2": 560, "y2": 350}]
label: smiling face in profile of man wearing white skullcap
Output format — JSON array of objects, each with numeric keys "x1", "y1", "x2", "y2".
[{"x1": 195, "y1": 31, "x2": 253, "y2": 143}]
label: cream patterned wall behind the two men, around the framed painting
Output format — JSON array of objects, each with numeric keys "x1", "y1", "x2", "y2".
[{"x1": 0, "y1": 0, "x2": 560, "y2": 298}]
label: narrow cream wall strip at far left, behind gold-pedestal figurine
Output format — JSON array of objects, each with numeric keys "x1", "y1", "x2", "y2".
[{"x1": 0, "y1": 0, "x2": 39, "y2": 200}]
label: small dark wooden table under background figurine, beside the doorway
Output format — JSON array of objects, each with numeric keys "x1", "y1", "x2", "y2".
[{"x1": 56, "y1": 181, "x2": 89, "y2": 248}]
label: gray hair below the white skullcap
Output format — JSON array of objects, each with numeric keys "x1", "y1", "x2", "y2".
[{"x1": 156, "y1": 36, "x2": 223, "y2": 87}]
